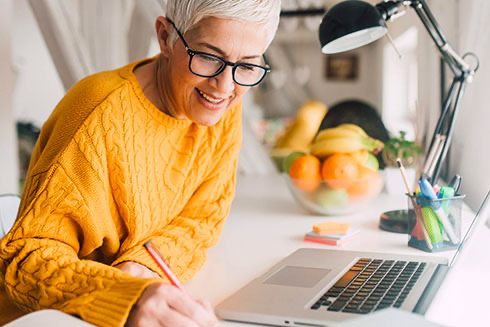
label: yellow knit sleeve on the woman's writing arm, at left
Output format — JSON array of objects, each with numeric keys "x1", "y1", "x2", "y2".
[{"x1": 0, "y1": 128, "x2": 157, "y2": 326}]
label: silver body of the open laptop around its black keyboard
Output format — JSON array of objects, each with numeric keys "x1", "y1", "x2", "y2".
[{"x1": 216, "y1": 192, "x2": 490, "y2": 327}]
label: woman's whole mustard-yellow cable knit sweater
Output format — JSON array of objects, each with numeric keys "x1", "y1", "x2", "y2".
[{"x1": 0, "y1": 59, "x2": 241, "y2": 326}]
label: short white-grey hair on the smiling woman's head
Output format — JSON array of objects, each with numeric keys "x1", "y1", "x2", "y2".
[{"x1": 166, "y1": 0, "x2": 281, "y2": 50}]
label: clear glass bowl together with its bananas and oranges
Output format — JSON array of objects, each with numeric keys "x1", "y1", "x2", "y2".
[{"x1": 284, "y1": 124, "x2": 383, "y2": 215}]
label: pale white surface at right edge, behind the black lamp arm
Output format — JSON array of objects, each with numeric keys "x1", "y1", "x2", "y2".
[{"x1": 450, "y1": 0, "x2": 490, "y2": 210}]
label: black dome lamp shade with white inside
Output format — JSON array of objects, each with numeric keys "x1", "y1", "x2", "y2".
[{"x1": 319, "y1": 0, "x2": 388, "y2": 54}]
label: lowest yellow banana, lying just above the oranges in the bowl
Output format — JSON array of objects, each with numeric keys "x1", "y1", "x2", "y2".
[{"x1": 310, "y1": 136, "x2": 383, "y2": 158}]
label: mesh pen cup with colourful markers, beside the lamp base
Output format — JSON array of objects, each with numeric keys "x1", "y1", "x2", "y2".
[{"x1": 407, "y1": 194, "x2": 465, "y2": 252}]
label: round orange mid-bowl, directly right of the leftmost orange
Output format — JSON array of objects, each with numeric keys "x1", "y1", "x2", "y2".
[{"x1": 322, "y1": 153, "x2": 359, "y2": 190}]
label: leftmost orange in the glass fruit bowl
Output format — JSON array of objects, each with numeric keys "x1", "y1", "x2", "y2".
[{"x1": 289, "y1": 154, "x2": 321, "y2": 191}]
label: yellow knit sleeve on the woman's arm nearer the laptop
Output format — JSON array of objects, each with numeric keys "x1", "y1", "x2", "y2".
[{"x1": 110, "y1": 111, "x2": 241, "y2": 282}]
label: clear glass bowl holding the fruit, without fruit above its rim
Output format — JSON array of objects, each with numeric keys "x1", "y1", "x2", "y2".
[{"x1": 284, "y1": 174, "x2": 383, "y2": 215}]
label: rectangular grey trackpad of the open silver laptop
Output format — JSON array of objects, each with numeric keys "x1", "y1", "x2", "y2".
[{"x1": 264, "y1": 266, "x2": 332, "y2": 288}]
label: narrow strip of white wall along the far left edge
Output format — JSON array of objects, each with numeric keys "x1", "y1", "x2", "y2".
[{"x1": 0, "y1": 0, "x2": 19, "y2": 193}]
